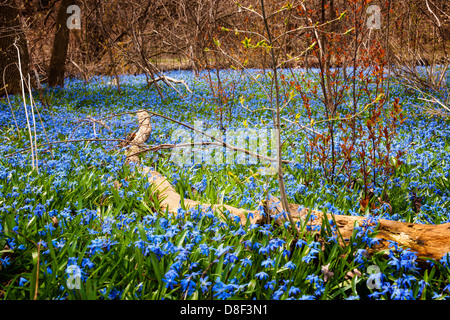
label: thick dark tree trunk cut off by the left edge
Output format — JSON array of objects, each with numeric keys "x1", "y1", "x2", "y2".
[{"x1": 0, "y1": 0, "x2": 29, "y2": 97}]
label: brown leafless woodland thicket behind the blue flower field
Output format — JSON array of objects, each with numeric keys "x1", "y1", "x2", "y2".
[{"x1": 0, "y1": 0, "x2": 450, "y2": 92}]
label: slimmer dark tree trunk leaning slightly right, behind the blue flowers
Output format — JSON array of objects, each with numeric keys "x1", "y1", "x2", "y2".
[{"x1": 48, "y1": 0, "x2": 74, "y2": 87}]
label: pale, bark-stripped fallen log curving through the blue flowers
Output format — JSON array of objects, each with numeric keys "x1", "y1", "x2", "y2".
[{"x1": 126, "y1": 110, "x2": 450, "y2": 260}]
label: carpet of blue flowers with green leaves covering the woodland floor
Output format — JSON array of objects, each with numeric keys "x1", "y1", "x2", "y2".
[{"x1": 0, "y1": 71, "x2": 450, "y2": 300}]
